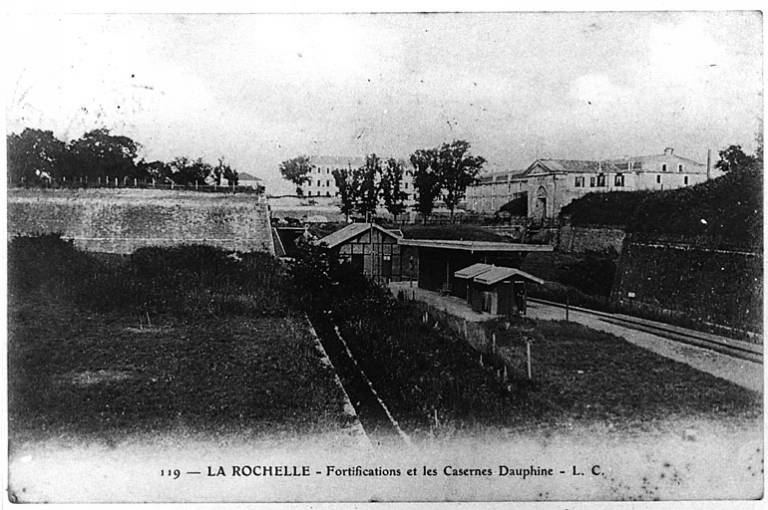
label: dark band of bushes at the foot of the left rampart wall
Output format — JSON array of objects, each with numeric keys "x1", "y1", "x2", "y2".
[{"x1": 8, "y1": 236, "x2": 289, "y2": 317}]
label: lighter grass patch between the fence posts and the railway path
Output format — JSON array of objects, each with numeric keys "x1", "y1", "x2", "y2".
[{"x1": 500, "y1": 321, "x2": 762, "y2": 428}]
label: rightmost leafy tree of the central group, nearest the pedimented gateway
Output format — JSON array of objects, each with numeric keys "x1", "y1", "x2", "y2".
[{"x1": 437, "y1": 140, "x2": 485, "y2": 221}]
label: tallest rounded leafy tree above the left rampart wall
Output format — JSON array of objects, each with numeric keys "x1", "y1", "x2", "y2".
[{"x1": 62, "y1": 128, "x2": 140, "y2": 180}]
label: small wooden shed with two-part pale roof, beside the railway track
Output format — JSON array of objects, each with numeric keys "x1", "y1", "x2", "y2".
[{"x1": 454, "y1": 264, "x2": 544, "y2": 315}]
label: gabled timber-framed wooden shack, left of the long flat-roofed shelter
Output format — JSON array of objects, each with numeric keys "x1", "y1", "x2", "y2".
[{"x1": 316, "y1": 223, "x2": 411, "y2": 283}]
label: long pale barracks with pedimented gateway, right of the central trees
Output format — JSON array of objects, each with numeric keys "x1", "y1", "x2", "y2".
[{"x1": 466, "y1": 147, "x2": 721, "y2": 219}]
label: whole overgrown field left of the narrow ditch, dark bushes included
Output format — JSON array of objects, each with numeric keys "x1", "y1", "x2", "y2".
[{"x1": 8, "y1": 239, "x2": 346, "y2": 445}]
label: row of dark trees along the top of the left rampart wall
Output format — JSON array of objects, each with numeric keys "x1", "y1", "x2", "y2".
[{"x1": 7, "y1": 128, "x2": 239, "y2": 186}]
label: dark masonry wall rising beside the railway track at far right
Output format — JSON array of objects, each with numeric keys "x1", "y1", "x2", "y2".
[{"x1": 611, "y1": 237, "x2": 763, "y2": 335}]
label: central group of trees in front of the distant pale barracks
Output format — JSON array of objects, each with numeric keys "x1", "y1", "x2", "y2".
[{"x1": 280, "y1": 140, "x2": 485, "y2": 222}]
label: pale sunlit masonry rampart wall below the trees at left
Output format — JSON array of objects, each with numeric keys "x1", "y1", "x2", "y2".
[{"x1": 8, "y1": 189, "x2": 274, "y2": 254}]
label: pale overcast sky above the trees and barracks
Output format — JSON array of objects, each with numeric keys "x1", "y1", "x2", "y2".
[{"x1": 5, "y1": 12, "x2": 763, "y2": 192}]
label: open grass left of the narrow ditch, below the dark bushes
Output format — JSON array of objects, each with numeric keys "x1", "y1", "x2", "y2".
[{"x1": 8, "y1": 241, "x2": 343, "y2": 440}]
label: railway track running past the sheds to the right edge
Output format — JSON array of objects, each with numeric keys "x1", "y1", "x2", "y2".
[{"x1": 528, "y1": 298, "x2": 763, "y2": 364}]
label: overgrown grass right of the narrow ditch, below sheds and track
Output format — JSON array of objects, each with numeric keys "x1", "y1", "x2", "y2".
[{"x1": 320, "y1": 276, "x2": 762, "y2": 435}]
